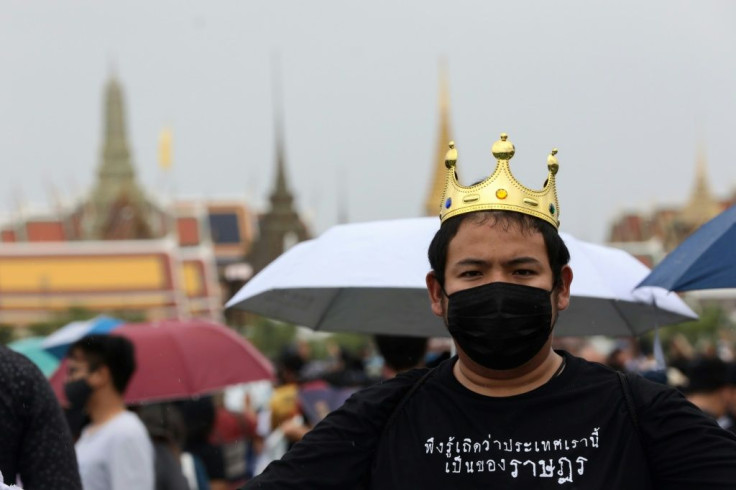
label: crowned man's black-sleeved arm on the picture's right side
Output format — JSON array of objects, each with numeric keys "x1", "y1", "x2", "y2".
[{"x1": 629, "y1": 376, "x2": 736, "y2": 490}]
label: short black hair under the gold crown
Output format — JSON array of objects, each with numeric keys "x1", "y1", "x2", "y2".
[{"x1": 427, "y1": 211, "x2": 570, "y2": 289}]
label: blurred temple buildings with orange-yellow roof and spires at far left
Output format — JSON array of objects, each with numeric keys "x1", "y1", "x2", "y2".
[{"x1": 0, "y1": 76, "x2": 308, "y2": 325}]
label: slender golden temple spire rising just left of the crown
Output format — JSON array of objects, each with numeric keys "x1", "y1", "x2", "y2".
[{"x1": 424, "y1": 58, "x2": 452, "y2": 216}]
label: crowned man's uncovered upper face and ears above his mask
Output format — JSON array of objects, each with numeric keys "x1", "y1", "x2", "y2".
[{"x1": 427, "y1": 219, "x2": 572, "y2": 319}]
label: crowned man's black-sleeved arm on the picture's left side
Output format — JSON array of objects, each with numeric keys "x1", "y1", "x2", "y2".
[{"x1": 244, "y1": 371, "x2": 422, "y2": 490}]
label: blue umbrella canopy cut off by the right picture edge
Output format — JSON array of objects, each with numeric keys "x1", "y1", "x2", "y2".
[{"x1": 639, "y1": 204, "x2": 736, "y2": 291}]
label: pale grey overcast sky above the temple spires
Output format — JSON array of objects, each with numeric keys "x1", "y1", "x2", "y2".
[{"x1": 0, "y1": 0, "x2": 736, "y2": 241}]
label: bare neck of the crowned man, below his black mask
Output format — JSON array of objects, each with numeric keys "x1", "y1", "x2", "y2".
[{"x1": 453, "y1": 348, "x2": 563, "y2": 397}]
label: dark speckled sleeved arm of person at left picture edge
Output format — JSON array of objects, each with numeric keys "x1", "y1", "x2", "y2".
[{"x1": 16, "y1": 356, "x2": 82, "y2": 490}]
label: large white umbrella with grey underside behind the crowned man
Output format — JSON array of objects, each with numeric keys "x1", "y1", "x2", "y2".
[{"x1": 227, "y1": 218, "x2": 696, "y2": 336}]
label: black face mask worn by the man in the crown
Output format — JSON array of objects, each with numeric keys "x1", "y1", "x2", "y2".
[{"x1": 447, "y1": 282, "x2": 552, "y2": 370}]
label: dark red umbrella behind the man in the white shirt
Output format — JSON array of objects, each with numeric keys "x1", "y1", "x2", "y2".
[{"x1": 50, "y1": 320, "x2": 273, "y2": 403}]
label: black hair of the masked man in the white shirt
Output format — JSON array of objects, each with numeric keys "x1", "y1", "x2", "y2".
[{"x1": 67, "y1": 335, "x2": 136, "y2": 395}]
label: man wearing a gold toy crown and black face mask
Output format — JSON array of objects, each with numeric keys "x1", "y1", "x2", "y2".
[{"x1": 246, "y1": 135, "x2": 736, "y2": 490}]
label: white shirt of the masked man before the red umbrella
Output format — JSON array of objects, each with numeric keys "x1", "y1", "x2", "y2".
[{"x1": 75, "y1": 411, "x2": 155, "y2": 490}]
